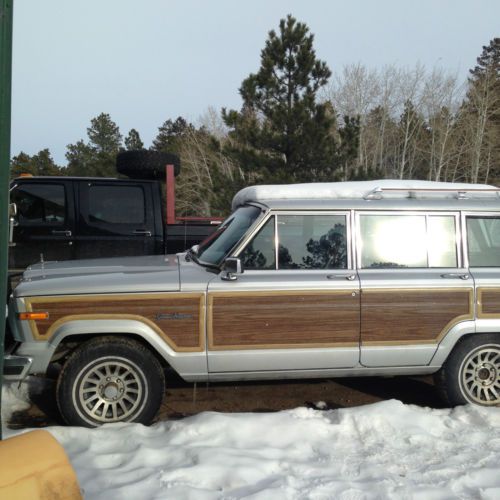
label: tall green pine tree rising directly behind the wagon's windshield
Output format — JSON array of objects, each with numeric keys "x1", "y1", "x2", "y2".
[{"x1": 223, "y1": 15, "x2": 344, "y2": 182}]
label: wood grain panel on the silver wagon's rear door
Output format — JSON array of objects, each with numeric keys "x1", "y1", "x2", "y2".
[{"x1": 361, "y1": 289, "x2": 473, "y2": 345}]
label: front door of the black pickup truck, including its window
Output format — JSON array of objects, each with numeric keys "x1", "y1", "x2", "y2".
[{"x1": 9, "y1": 179, "x2": 74, "y2": 272}]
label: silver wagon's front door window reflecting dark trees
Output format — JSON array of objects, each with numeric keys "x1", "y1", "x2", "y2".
[{"x1": 240, "y1": 215, "x2": 347, "y2": 270}]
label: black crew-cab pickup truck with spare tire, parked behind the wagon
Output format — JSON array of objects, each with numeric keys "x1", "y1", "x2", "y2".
[{"x1": 9, "y1": 151, "x2": 220, "y2": 276}]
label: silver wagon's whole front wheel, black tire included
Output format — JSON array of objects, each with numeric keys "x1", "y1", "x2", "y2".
[{"x1": 56, "y1": 337, "x2": 165, "y2": 427}]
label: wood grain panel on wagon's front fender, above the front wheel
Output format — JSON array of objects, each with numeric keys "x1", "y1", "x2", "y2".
[{"x1": 26, "y1": 293, "x2": 205, "y2": 350}]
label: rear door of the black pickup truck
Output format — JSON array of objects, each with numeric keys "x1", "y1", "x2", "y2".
[{"x1": 75, "y1": 179, "x2": 157, "y2": 259}]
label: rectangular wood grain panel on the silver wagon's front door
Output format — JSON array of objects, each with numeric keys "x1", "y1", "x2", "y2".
[{"x1": 209, "y1": 291, "x2": 359, "y2": 350}]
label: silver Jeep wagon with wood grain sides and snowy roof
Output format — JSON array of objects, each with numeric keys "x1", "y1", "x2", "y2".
[{"x1": 6, "y1": 181, "x2": 500, "y2": 426}]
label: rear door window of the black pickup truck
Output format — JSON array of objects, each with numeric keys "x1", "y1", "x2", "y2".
[{"x1": 89, "y1": 185, "x2": 146, "y2": 224}]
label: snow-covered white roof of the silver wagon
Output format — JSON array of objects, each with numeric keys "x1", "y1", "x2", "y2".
[{"x1": 232, "y1": 179, "x2": 497, "y2": 210}]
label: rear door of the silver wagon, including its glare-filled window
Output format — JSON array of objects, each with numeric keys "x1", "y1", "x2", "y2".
[{"x1": 356, "y1": 211, "x2": 474, "y2": 367}]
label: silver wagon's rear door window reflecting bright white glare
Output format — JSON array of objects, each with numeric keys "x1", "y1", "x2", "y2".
[{"x1": 359, "y1": 214, "x2": 458, "y2": 269}]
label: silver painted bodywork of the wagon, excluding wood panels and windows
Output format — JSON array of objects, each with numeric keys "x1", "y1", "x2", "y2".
[{"x1": 9, "y1": 196, "x2": 500, "y2": 381}]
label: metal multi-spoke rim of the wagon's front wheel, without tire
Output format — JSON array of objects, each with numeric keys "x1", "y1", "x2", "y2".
[{"x1": 73, "y1": 357, "x2": 148, "y2": 425}]
